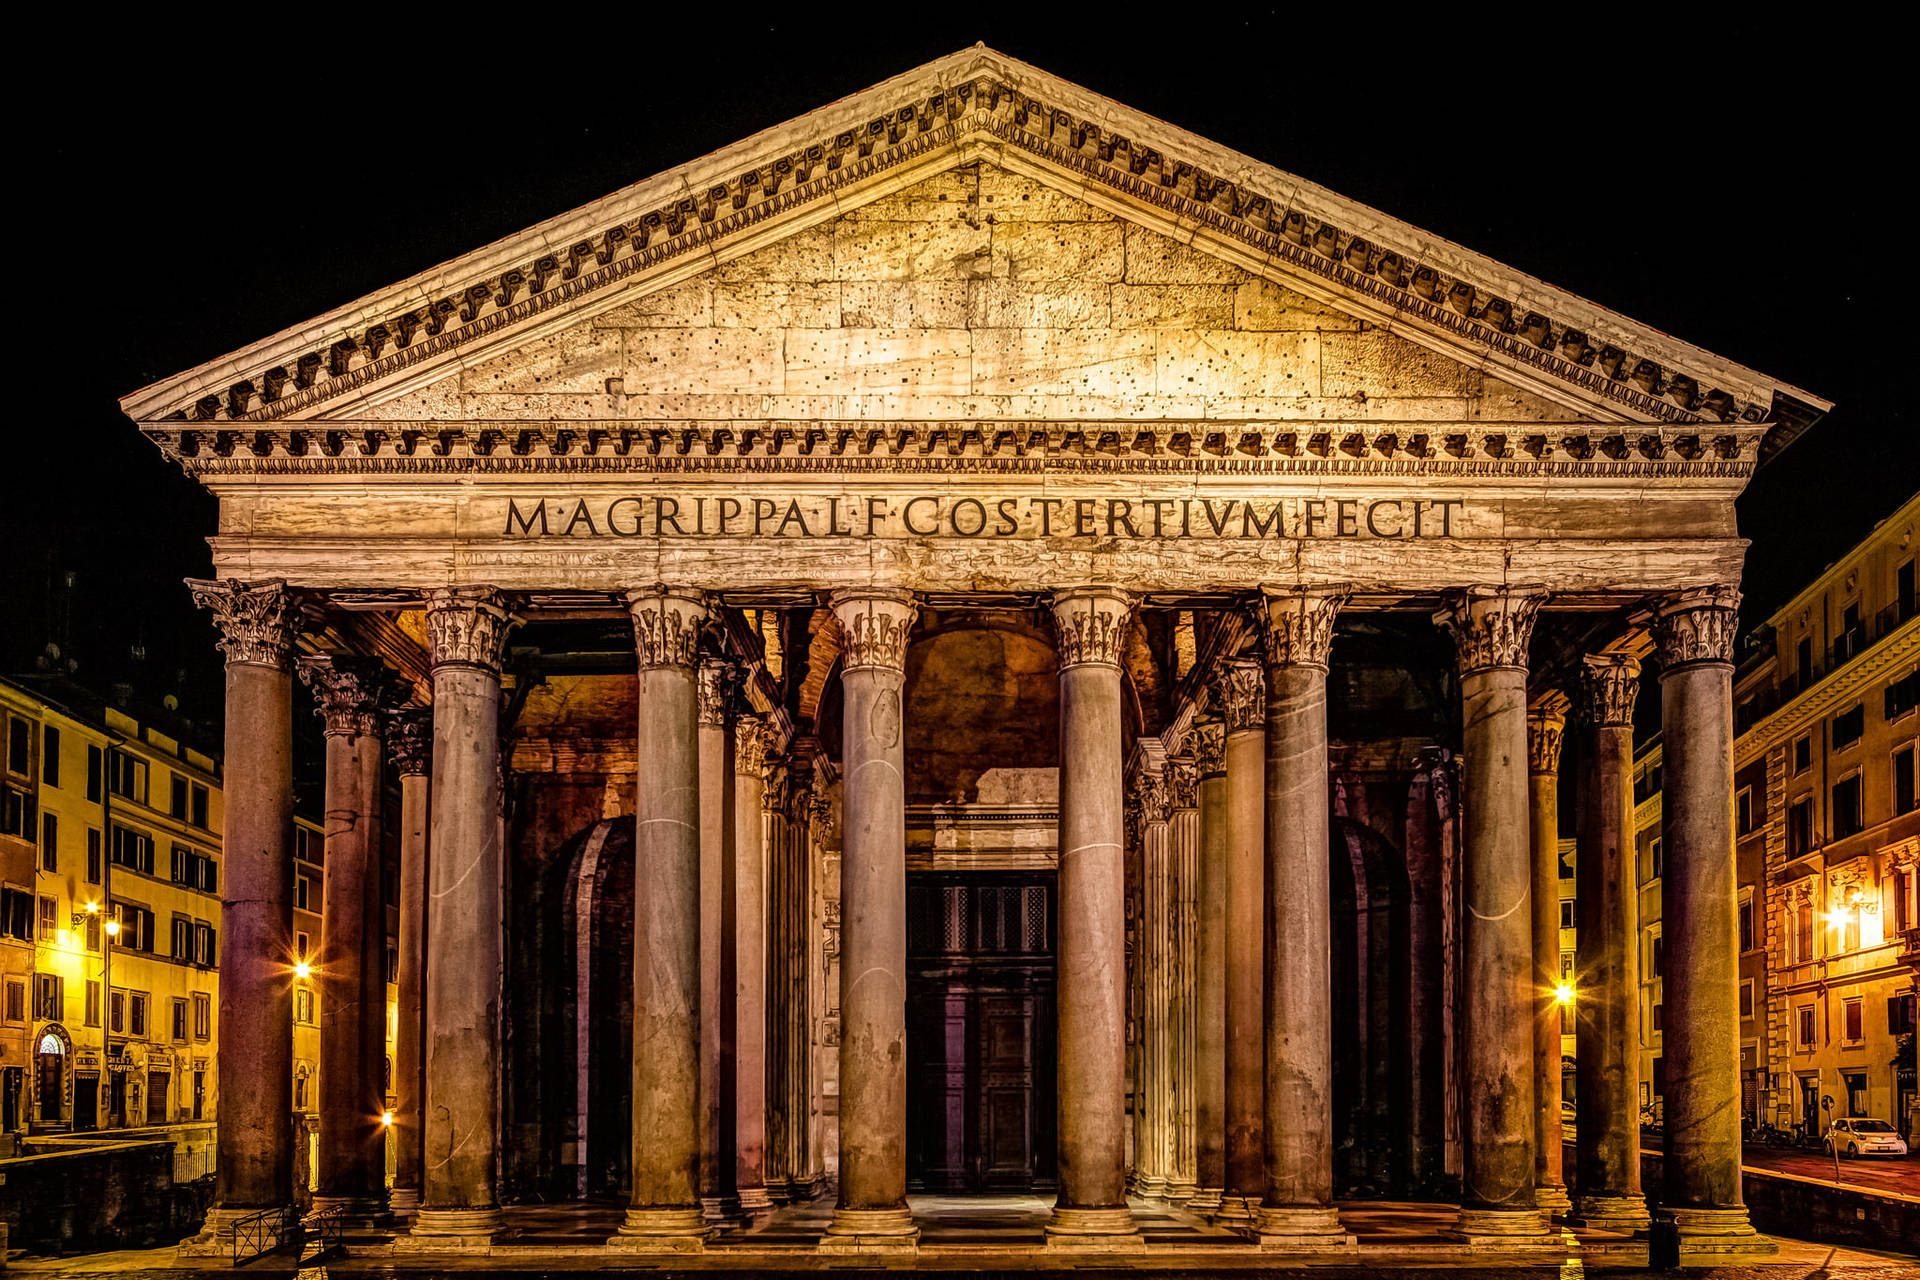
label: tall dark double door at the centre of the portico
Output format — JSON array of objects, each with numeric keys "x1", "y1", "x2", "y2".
[{"x1": 906, "y1": 873, "x2": 1054, "y2": 1194}]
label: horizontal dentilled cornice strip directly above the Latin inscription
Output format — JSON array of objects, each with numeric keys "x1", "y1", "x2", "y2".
[{"x1": 146, "y1": 418, "x2": 1768, "y2": 482}]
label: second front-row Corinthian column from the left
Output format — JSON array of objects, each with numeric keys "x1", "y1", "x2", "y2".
[{"x1": 411, "y1": 587, "x2": 513, "y2": 1249}]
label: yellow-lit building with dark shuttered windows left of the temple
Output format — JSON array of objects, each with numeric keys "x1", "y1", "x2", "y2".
[{"x1": 0, "y1": 679, "x2": 396, "y2": 1174}]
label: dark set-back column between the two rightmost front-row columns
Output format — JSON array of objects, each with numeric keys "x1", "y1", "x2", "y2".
[{"x1": 1571, "y1": 654, "x2": 1647, "y2": 1232}]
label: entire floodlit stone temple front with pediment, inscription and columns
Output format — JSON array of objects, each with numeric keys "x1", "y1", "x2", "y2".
[{"x1": 123, "y1": 48, "x2": 1828, "y2": 1259}]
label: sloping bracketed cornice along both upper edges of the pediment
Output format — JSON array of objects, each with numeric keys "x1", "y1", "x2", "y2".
[{"x1": 121, "y1": 48, "x2": 1828, "y2": 450}]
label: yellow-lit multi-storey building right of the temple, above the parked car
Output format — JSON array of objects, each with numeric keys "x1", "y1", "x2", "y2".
[{"x1": 1634, "y1": 495, "x2": 1920, "y2": 1138}]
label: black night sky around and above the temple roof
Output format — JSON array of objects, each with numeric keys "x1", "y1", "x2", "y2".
[{"x1": 0, "y1": 17, "x2": 1920, "y2": 729}]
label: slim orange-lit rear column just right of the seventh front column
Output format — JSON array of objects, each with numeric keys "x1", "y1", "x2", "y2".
[{"x1": 1526, "y1": 693, "x2": 1572, "y2": 1213}]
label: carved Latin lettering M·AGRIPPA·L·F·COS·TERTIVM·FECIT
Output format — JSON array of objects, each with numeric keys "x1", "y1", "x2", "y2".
[{"x1": 501, "y1": 493, "x2": 1465, "y2": 539}]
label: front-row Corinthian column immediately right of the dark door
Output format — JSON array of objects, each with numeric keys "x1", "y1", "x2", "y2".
[{"x1": 1046, "y1": 587, "x2": 1139, "y2": 1247}]
